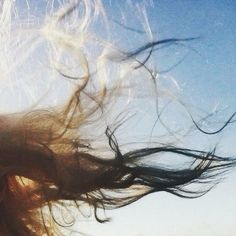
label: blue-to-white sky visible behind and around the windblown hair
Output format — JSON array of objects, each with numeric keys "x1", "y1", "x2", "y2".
[{"x1": 0, "y1": 0, "x2": 236, "y2": 236}]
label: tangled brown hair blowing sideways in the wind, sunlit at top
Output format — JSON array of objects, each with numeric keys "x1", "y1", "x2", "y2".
[{"x1": 0, "y1": 0, "x2": 234, "y2": 236}]
